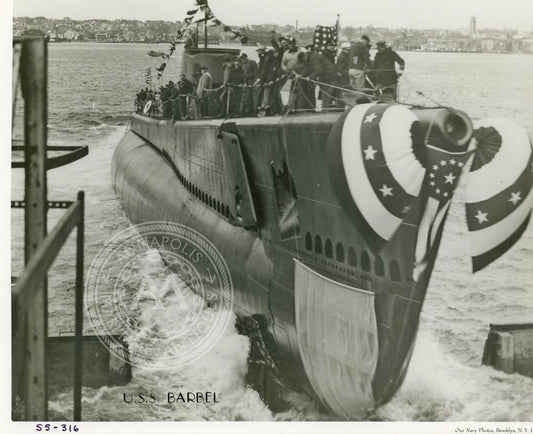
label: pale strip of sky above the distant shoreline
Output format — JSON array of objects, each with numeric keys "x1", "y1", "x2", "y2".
[{"x1": 9, "y1": 0, "x2": 533, "y2": 30}]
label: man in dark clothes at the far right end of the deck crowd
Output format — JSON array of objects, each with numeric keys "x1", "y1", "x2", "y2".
[{"x1": 373, "y1": 41, "x2": 405, "y2": 99}]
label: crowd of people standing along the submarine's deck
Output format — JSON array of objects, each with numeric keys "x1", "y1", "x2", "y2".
[{"x1": 135, "y1": 35, "x2": 405, "y2": 120}]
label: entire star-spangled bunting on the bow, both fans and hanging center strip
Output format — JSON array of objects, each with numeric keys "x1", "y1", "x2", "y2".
[{"x1": 328, "y1": 104, "x2": 533, "y2": 274}]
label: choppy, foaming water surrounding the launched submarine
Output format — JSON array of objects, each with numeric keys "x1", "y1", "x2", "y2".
[{"x1": 12, "y1": 43, "x2": 533, "y2": 421}]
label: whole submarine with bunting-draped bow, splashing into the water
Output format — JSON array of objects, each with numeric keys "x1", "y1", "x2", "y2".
[{"x1": 112, "y1": 48, "x2": 533, "y2": 420}]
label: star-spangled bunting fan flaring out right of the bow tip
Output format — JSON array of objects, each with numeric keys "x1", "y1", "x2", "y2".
[{"x1": 465, "y1": 118, "x2": 533, "y2": 272}]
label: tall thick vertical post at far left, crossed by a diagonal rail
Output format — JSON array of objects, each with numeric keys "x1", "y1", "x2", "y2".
[{"x1": 20, "y1": 38, "x2": 48, "y2": 420}]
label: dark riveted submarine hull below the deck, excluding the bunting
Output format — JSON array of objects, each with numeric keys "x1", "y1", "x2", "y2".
[{"x1": 112, "y1": 113, "x2": 441, "y2": 420}]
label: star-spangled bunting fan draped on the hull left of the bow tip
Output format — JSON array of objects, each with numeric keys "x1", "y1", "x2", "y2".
[{"x1": 341, "y1": 104, "x2": 425, "y2": 252}]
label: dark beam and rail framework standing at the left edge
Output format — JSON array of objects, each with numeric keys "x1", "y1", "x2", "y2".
[{"x1": 11, "y1": 37, "x2": 88, "y2": 421}]
